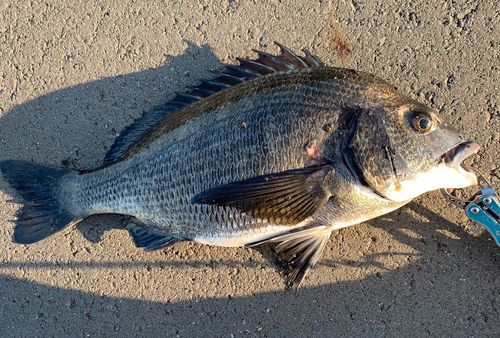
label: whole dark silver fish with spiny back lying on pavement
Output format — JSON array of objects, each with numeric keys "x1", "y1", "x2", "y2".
[{"x1": 0, "y1": 43, "x2": 480, "y2": 287}]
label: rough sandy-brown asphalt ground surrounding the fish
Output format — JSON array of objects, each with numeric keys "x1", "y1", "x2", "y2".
[{"x1": 0, "y1": 0, "x2": 500, "y2": 337}]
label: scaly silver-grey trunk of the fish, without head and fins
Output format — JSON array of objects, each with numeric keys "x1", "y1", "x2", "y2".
[{"x1": 61, "y1": 68, "x2": 406, "y2": 246}]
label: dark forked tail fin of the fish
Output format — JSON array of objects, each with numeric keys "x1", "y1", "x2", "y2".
[{"x1": 0, "y1": 160, "x2": 81, "y2": 244}]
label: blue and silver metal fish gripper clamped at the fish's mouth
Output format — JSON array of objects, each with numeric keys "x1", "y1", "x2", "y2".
[{"x1": 441, "y1": 166, "x2": 500, "y2": 246}]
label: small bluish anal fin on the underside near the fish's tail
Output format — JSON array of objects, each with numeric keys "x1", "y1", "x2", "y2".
[{"x1": 125, "y1": 223, "x2": 184, "y2": 251}]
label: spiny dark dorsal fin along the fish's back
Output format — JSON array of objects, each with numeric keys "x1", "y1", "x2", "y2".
[{"x1": 104, "y1": 42, "x2": 323, "y2": 166}]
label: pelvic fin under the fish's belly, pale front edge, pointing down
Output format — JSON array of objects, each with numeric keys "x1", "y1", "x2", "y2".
[{"x1": 248, "y1": 226, "x2": 331, "y2": 288}]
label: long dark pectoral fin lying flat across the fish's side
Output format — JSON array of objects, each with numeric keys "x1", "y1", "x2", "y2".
[{"x1": 191, "y1": 165, "x2": 333, "y2": 224}]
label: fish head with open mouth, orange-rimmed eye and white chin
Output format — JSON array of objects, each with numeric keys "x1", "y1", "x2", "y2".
[{"x1": 342, "y1": 99, "x2": 479, "y2": 202}]
